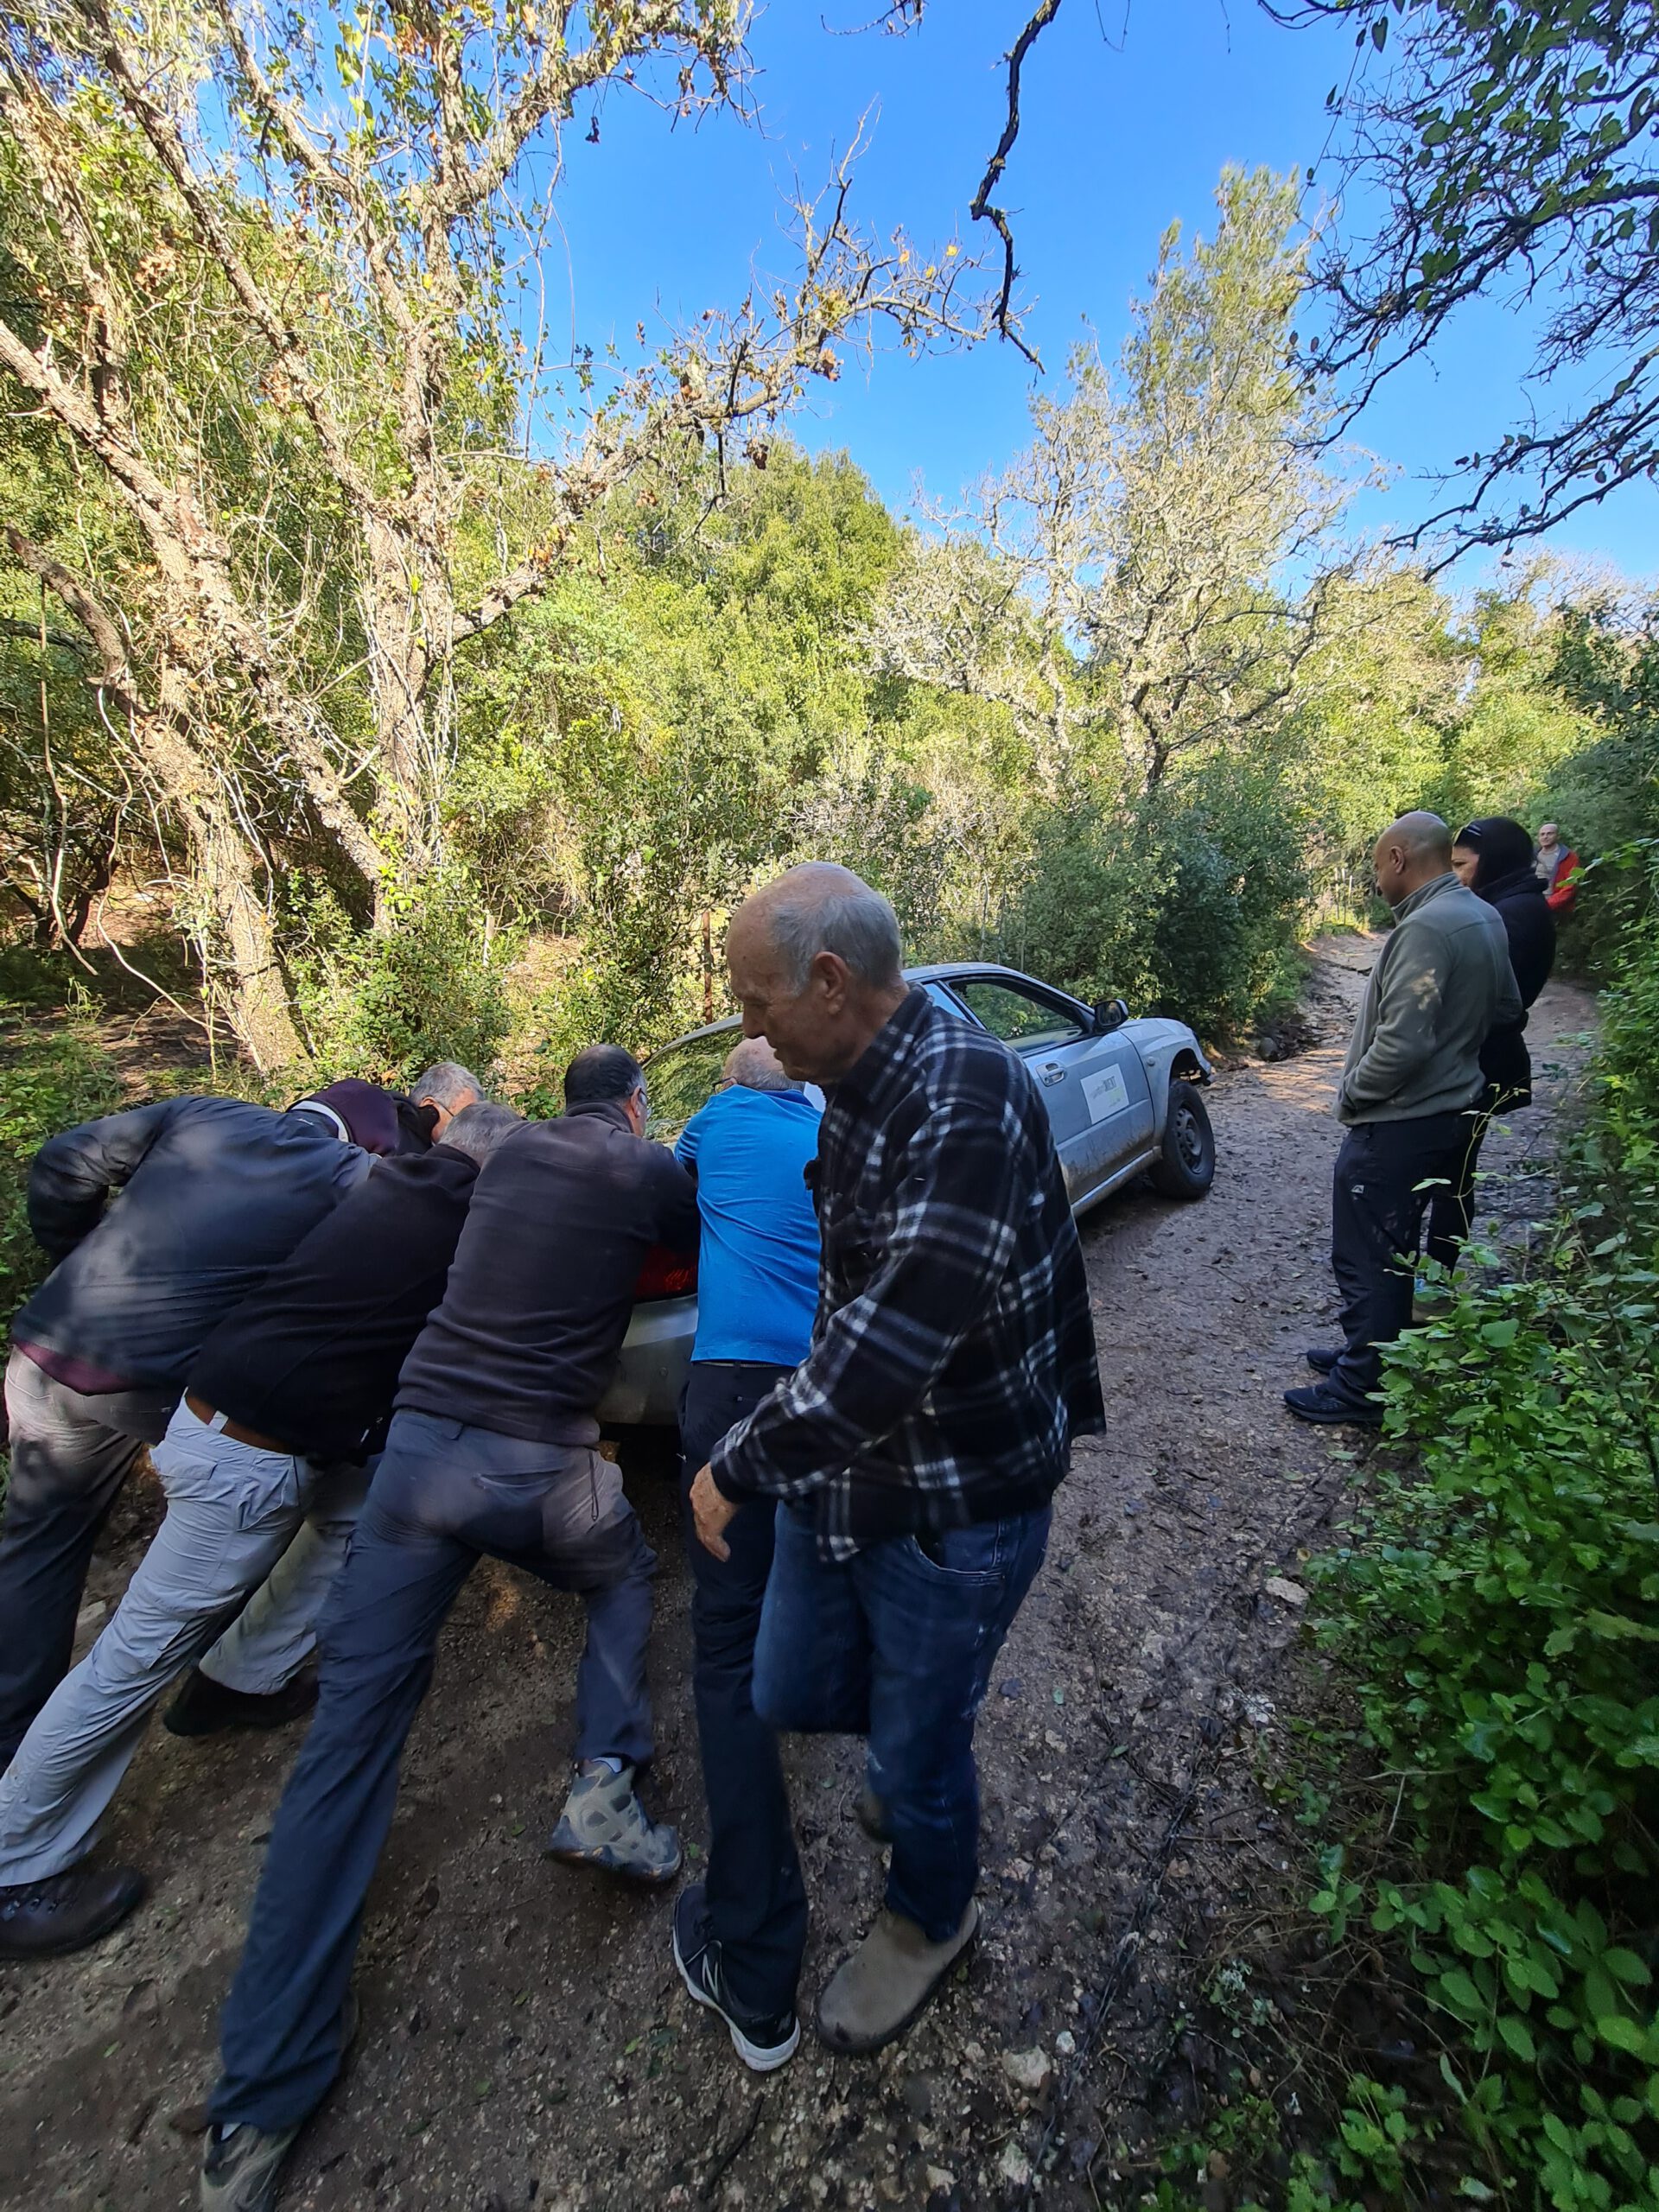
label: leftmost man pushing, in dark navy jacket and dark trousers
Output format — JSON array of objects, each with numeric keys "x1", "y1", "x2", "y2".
[{"x1": 0, "y1": 1097, "x2": 372, "y2": 1767}]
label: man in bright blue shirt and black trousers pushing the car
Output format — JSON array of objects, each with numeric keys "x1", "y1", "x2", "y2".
[{"x1": 675, "y1": 1038, "x2": 818, "y2": 2073}]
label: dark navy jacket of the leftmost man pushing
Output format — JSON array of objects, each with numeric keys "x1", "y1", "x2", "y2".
[{"x1": 11, "y1": 1097, "x2": 372, "y2": 1389}]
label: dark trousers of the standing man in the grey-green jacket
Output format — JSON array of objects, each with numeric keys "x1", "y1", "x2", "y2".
[{"x1": 1330, "y1": 1109, "x2": 1482, "y2": 1398}]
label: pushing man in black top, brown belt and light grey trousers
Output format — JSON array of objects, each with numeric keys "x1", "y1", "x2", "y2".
[{"x1": 0, "y1": 1103, "x2": 522, "y2": 1958}]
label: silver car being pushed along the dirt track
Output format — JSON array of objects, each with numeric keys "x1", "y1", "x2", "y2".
[{"x1": 600, "y1": 960, "x2": 1214, "y2": 1431}]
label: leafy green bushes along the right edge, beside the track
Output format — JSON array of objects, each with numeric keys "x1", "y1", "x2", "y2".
[{"x1": 1314, "y1": 854, "x2": 1659, "y2": 2212}]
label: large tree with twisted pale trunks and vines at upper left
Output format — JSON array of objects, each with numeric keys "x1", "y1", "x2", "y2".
[{"x1": 0, "y1": 0, "x2": 988, "y2": 1066}]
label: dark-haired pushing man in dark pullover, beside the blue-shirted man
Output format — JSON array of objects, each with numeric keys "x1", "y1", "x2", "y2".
[{"x1": 201, "y1": 1044, "x2": 696, "y2": 2212}]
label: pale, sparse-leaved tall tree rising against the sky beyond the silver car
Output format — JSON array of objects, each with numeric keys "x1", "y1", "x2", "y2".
[{"x1": 872, "y1": 170, "x2": 1351, "y2": 797}]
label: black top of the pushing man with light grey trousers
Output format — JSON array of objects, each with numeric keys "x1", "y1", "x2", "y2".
[{"x1": 188, "y1": 1144, "x2": 478, "y2": 1460}]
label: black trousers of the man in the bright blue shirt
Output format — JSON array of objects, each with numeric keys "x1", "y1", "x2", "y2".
[{"x1": 679, "y1": 1360, "x2": 807, "y2": 2018}]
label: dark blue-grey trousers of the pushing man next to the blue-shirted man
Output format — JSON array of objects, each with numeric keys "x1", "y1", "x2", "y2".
[{"x1": 210, "y1": 1411, "x2": 657, "y2": 2128}]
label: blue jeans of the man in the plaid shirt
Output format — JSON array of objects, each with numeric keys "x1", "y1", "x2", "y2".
[{"x1": 754, "y1": 1506, "x2": 1048, "y2": 1942}]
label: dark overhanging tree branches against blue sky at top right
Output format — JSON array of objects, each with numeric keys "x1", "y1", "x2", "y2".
[{"x1": 1263, "y1": 0, "x2": 1659, "y2": 560}]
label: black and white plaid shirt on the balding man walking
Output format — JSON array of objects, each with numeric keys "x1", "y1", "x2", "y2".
[{"x1": 710, "y1": 988, "x2": 1106, "y2": 1560}]
